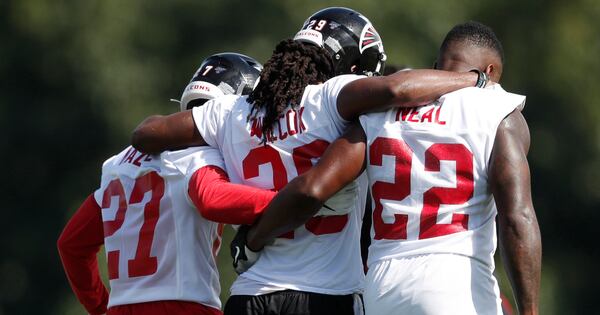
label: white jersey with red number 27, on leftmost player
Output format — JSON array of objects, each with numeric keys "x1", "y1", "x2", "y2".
[{"x1": 94, "y1": 147, "x2": 224, "y2": 309}]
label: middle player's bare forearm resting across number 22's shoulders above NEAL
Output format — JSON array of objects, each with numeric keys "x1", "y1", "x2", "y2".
[{"x1": 389, "y1": 70, "x2": 478, "y2": 107}]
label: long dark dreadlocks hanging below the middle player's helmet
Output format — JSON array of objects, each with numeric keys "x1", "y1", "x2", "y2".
[{"x1": 248, "y1": 39, "x2": 334, "y2": 144}]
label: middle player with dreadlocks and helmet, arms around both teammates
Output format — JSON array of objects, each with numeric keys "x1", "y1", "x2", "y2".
[{"x1": 133, "y1": 8, "x2": 483, "y2": 314}]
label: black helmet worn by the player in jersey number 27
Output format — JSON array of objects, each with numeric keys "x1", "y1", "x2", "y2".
[{"x1": 180, "y1": 52, "x2": 262, "y2": 111}]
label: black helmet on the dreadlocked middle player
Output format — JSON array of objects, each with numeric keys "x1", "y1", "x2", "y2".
[{"x1": 294, "y1": 7, "x2": 386, "y2": 76}]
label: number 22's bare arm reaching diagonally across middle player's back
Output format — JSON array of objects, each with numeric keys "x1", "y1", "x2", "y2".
[{"x1": 247, "y1": 123, "x2": 366, "y2": 250}]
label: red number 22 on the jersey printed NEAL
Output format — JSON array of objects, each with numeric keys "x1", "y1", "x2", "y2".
[{"x1": 369, "y1": 137, "x2": 474, "y2": 240}]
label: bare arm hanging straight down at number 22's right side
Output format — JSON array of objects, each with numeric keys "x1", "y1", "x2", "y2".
[{"x1": 489, "y1": 110, "x2": 542, "y2": 314}]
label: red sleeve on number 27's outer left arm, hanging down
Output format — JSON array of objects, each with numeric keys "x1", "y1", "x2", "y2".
[{"x1": 57, "y1": 195, "x2": 108, "y2": 314}]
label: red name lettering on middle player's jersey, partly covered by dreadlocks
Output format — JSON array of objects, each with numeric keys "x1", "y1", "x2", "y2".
[{"x1": 250, "y1": 106, "x2": 306, "y2": 142}]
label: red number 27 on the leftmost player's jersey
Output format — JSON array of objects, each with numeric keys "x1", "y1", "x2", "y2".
[{"x1": 102, "y1": 172, "x2": 165, "y2": 280}]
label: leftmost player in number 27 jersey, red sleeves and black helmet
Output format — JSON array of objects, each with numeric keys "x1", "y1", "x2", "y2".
[{"x1": 58, "y1": 53, "x2": 273, "y2": 315}]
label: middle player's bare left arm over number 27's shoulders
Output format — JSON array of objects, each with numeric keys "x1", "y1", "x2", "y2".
[{"x1": 131, "y1": 110, "x2": 206, "y2": 154}]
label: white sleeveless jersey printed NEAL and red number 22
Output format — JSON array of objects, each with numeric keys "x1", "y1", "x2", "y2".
[{"x1": 360, "y1": 86, "x2": 525, "y2": 268}]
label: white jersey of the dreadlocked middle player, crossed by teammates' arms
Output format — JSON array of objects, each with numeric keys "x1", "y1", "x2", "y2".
[{"x1": 193, "y1": 75, "x2": 365, "y2": 295}]
